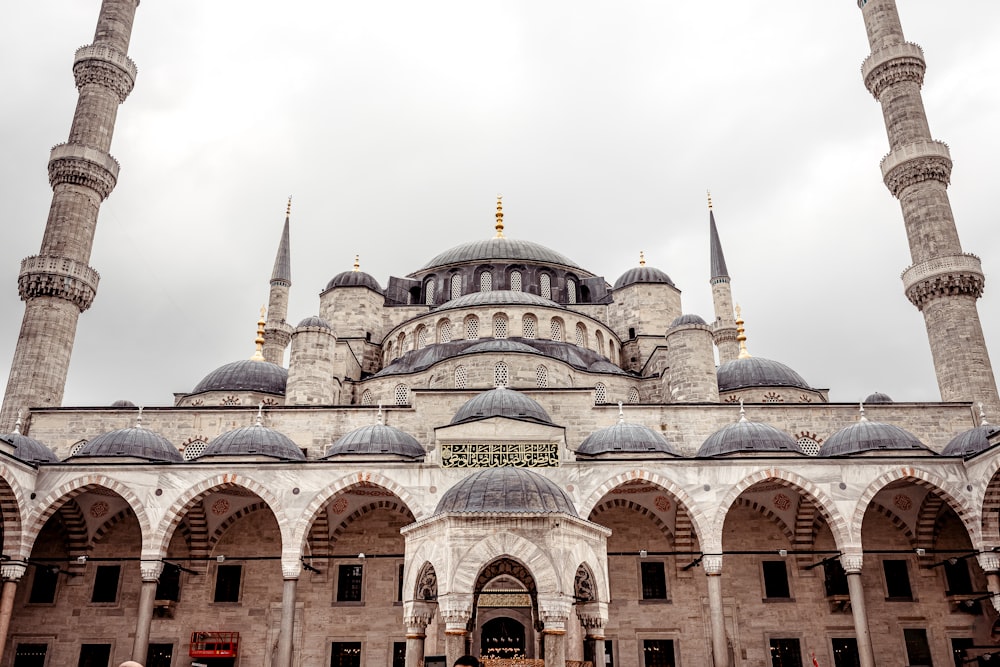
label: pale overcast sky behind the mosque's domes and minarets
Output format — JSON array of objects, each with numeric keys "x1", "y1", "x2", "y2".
[{"x1": 0, "y1": 0, "x2": 1000, "y2": 408}]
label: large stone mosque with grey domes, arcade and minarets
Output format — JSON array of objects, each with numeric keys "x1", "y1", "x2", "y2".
[{"x1": 0, "y1": 0, "x2": 1000, "y2": 667}]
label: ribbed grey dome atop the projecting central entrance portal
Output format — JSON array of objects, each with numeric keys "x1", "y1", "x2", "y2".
[{"x1": 434, "y1": 468, "x2": 579, "y2": 516}]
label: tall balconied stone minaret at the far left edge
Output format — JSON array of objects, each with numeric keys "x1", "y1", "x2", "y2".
[{"x1": 0, "y1": 0, "x2": 139, "y2": 431}]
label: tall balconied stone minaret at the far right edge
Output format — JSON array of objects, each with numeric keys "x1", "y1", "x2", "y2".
[{"x1": 858, "y1": 0, "x2": 1000, "y2": 410}]
